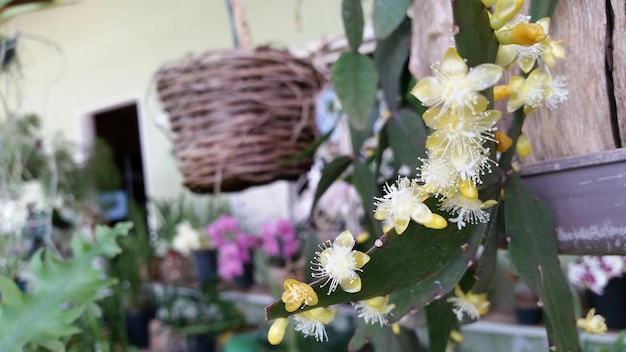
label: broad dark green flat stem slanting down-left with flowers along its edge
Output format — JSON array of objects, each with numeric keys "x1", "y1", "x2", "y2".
[{"x1": 266, "y1": 199, "x2": 486, "y2": 319}]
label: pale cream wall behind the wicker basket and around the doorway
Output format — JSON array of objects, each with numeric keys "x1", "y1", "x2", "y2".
[{"x1": 0, "y1": 0, "x2": 343, "y2": 206}]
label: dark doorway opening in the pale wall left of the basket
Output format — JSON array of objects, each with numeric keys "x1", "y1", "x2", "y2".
[{"x1": 92, "y1": 104, "x2": 146, "y2": 222}]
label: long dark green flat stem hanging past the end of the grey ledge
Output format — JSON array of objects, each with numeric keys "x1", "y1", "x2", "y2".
[{"x1": 504, "y1": 174, "x2": 580, "y2": 351}]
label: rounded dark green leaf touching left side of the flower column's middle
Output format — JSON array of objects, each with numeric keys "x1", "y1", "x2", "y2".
[{"x1": 385, "y1": 109, "x2": 427, "y2": 174}]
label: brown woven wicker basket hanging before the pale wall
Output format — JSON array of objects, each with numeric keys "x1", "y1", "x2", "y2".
[{"x1": 156, "y1": 47, "x2": 325, "y2": 193}]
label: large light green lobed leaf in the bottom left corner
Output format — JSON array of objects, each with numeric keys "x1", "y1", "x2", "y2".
[{"x1": 0, "y1": 223, "x2": 131, "y2": 352}]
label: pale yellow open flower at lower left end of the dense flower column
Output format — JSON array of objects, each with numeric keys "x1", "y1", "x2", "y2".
[{"x1": 374, "y1": 177, "x2": 447, "y2": 235}]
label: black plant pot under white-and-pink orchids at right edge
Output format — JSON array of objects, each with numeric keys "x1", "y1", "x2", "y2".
[{"x1": 586, "y1": 276, "x2": 626, "y2": 330}]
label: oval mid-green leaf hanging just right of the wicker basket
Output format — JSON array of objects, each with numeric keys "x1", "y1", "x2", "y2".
[{"x1": 331, "y1": 52, "x2": 378, "y2": 131}]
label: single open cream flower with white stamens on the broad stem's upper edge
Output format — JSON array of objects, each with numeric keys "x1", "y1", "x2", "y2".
[{"x1": 311, "y1": 230, "x2": 370, "y2": 295}]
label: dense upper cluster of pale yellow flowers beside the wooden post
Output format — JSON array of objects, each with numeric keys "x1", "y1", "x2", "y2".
[{"x1": 375, "y1": 0, "x2": 567, "y2": 234}]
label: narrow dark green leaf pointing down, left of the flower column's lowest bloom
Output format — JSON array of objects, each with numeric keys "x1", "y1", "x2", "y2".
[{"x1": 352, "y1": 161, "x2": 383, "y2": 244}]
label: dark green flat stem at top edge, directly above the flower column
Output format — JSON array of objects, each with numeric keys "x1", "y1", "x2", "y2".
[{"x1": 452, "y1": 0, "x2": 498, "y2": 67}]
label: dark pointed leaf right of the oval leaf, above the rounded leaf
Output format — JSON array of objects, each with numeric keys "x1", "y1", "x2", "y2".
[{"x1": 374, "y1": 17, "x2": 411, "y2": 112}]
